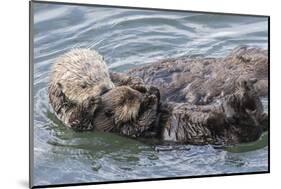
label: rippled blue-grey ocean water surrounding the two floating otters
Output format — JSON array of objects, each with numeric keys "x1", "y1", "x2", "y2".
[{"x1": 30, "y1": 3, "x2": 268, "y2": 185}]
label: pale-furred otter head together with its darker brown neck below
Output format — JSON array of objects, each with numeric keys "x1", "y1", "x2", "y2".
[{"x1": 48, "y1": 49, "x2": 114, "y2": 130}]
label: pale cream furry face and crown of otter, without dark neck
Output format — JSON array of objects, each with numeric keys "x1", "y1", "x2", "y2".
[{"x1": 51, "y1": 49, "x2": 114, "y2": 111}]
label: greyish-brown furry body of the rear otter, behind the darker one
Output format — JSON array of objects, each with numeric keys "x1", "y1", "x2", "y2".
[{"x1": 128, "y1": 47, "x2": 268, "y2": 105}]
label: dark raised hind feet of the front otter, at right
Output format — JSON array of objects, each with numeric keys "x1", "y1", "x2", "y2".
[{"x1": 223, "y1": 78, "x2": 267, "y2": 128}]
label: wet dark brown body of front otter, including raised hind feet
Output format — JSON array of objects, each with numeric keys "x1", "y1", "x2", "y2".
[{"x1": 162, "y1": 80, "x2": 267, "y2": 144}]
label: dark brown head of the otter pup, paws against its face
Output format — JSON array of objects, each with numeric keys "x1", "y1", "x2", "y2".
[{"x1": 93, "y1": 86, "x2": 160, "y2": 137}]
